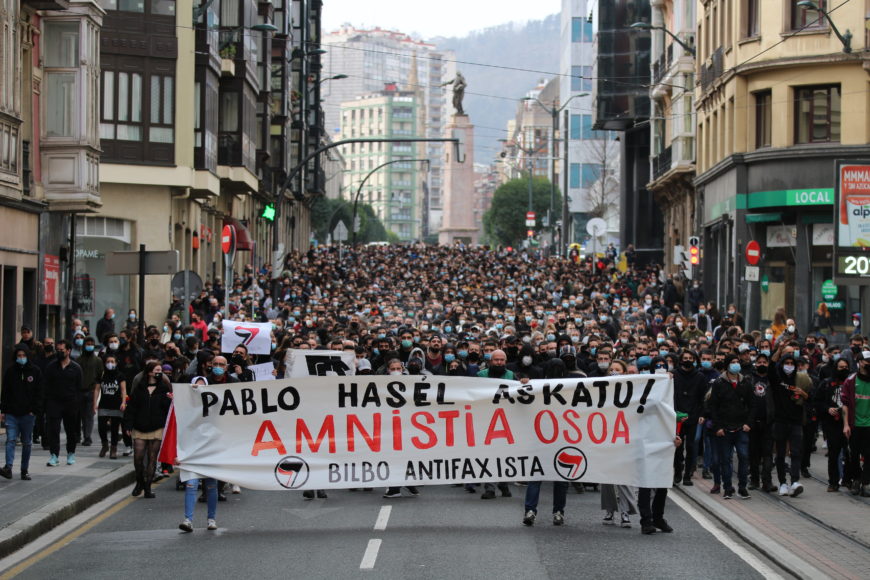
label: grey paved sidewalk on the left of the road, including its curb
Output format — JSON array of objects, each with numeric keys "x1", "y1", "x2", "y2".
[{"x1": 0, "y1": 430, "x2": 135, "y2": 558}]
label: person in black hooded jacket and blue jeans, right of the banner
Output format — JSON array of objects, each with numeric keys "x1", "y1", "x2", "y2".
[{"x1": 708, "y1": 354, "x2": 755, "y2": 499}]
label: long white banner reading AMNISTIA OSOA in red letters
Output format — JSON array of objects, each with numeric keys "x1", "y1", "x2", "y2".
[{"x1": 174, "y1": 375, "x2": 677, "y2": 490}]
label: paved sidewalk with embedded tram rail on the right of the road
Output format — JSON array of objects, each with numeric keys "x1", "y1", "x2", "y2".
[{"x1": 678, "y1": 439, "x2": 870, "y2": 580}]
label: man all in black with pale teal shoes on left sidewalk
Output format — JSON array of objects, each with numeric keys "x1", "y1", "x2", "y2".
[{"x1": 44, "y1": 340, "x2": 82, "y2": 467}]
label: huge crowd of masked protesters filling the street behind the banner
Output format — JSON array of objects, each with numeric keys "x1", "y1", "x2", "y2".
[{"x1": 0, "y1": 245, "x2": 870, "y2": 533}]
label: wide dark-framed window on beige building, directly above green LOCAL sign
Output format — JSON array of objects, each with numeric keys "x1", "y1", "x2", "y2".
[{"x1": 795, "y1": 85, "x2": 840, "y2": 143}]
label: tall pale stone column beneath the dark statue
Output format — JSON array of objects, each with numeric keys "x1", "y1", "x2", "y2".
[{"x1": 438, "y1": 115, "x2": 481, "y2": 245}]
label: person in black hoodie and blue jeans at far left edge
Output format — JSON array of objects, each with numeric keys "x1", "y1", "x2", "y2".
[{"x1": 0, "y1": 345, "x2": 42, "y2": 481}]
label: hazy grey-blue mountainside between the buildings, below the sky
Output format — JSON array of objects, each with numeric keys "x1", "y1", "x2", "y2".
[{"x1": 427, "y1": 14, "x2": 560, "y2": 163}]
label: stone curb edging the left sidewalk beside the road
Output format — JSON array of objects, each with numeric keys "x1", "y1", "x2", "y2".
[{"x1": 0, "y1": 463, "x2": 136, "y2": 558}]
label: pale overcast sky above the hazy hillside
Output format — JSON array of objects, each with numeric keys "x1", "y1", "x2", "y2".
[{"x1": 323, "y1": 0, "x2": 562, "y2": 39}]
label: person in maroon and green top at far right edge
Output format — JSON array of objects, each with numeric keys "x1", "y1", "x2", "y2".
[{"x1": 840, "y1": 351, "x2": 870, "y2": 497}]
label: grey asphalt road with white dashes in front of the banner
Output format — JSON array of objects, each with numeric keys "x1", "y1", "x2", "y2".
[{"x1": 6, "y1": 480, "x2": 784, "y2": 580}]
